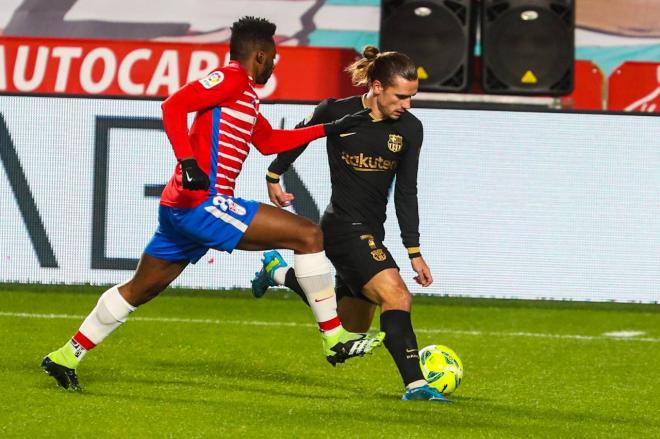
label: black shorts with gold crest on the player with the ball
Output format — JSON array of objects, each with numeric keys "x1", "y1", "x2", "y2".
[{"x1": 321, "y1": 221, "x2": 399, "y2": 302}]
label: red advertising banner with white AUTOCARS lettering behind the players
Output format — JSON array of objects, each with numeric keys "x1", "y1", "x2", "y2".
[{"x1": 0, "y1": 37, "x2": 360, "y2": 101}]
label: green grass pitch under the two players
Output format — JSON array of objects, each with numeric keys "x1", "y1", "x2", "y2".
[{"x1": 0, "y1": 285, "x2": 660, "y2": 439}]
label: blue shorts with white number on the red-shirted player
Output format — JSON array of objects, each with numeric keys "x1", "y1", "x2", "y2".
[{"x1": 144, "y1": 195, "x2": 259, "y2": 264}]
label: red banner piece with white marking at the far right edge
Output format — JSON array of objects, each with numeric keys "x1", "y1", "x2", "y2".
[{"x1": 607, "y1": 61, "x2": 660, "y2": 113}]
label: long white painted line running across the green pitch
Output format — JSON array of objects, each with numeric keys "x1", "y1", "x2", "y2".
[{"x1": 0, "y1": 311, "x2": 660, "y2": 343}]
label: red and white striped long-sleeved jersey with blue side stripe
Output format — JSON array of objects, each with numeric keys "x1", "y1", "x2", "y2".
[{"x1": 160, "y1": 61, "x2": 325, "y2": 208}]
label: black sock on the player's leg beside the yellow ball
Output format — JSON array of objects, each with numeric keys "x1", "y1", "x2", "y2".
[{"x1": 380, "y1": 310, "x2": 424, "y2": 386}]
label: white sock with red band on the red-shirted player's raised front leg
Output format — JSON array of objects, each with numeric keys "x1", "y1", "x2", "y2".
[{"x1": 293, "y1": 251, "x2": 341, "y2": 334}]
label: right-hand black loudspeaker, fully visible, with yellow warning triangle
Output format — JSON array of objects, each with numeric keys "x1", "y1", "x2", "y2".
[{"x1": 481, "y1": 0, "x2": 575, "y2": 96}]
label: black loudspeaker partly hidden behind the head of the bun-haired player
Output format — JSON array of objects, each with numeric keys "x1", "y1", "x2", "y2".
[{"x1": 380, "y1": 0, "x2": 476, "y2": 91}]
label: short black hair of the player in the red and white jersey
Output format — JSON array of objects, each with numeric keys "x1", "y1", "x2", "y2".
[{"x1": 229, "y1": 16, "x2": 276, "y2": 61}]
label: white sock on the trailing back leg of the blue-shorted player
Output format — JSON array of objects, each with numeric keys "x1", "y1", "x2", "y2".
[{"x1": 79, "y1": 285, "x2": 136, "y2": 345}]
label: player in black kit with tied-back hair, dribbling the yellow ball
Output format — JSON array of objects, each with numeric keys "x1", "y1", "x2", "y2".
[{"x1": 252, "y1": 46, "x2": 447, "y2": 401}]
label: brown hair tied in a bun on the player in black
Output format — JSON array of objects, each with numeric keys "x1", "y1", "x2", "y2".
[{"x1": 346, "y1": 45, "x2": 417, "y2": 87}]
